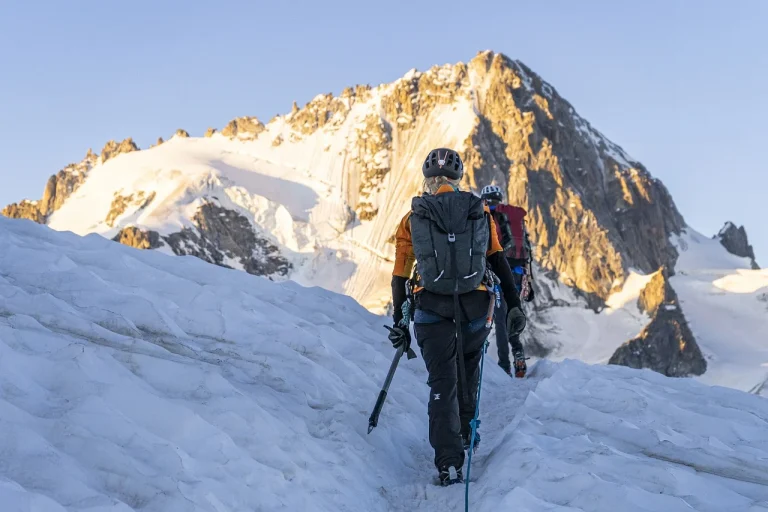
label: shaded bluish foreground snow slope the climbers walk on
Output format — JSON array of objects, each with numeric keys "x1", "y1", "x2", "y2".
[{"x1": 0, "y1": 218, "x2": 768, "y2": 512}]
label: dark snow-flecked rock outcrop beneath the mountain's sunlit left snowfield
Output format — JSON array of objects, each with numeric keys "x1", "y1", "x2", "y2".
[{"x1": 163, "y1": 202, "x2": 292, "y2": 277}]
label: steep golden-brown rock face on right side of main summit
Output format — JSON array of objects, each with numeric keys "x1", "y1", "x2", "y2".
[{"x1": 460, "y1": 52, "x2": 685, "y2": 299}]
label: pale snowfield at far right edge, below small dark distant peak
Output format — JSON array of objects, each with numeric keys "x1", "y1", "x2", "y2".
[{"x1": 671, "y1": 230, "x2": 768, "y2": 394}]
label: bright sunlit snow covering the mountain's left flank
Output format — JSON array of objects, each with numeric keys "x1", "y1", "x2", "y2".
[{"x1": 49, "y1": 136, "x2": 379, "y2": 302}]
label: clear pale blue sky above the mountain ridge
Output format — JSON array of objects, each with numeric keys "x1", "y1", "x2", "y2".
[{"x1": 0, "y1": 0, "x2": 768, "y2": 265}]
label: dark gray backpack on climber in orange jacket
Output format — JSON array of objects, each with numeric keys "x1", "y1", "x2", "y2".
[{"x1": 410, "y1": 192, "x2": 490, "y2": 295}]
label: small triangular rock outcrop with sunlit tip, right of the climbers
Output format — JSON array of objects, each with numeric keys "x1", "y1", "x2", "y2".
[{"x1": 608, "y1": 269, "x2": 707, "y2": 377}]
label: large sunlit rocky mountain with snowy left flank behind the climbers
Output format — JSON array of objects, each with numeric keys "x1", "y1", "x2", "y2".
[{"x1": 3, "y1": 51, "x2": 754, "y2": 375}]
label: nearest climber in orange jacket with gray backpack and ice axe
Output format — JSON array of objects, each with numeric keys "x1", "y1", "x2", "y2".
[{"x1": 388, "y1": 148, "x2": 526, "y2": 485}]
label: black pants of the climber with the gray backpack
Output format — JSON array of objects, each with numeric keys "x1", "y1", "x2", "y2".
[{"x1": 414, "y1": 310, "x2": 490, "y2": 469}]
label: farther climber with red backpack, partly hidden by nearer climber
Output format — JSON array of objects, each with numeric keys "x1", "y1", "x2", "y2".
[{"x1": 481, "y1": 185, "x2": 534, "y2": 378}]
